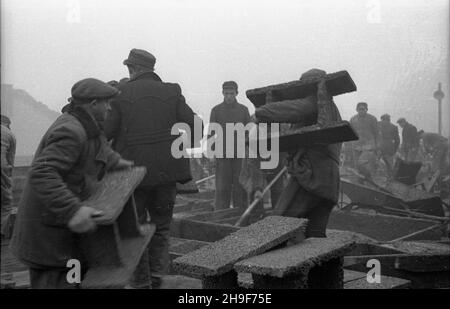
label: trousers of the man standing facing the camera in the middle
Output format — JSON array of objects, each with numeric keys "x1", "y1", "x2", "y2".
[{"x1": 214, "y1": 158, "x2": 247, "y2": 210}]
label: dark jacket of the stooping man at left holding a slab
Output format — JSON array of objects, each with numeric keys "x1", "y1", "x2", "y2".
[{"x1": 11, "y1": 108, "x2": 120, "y2": 267}]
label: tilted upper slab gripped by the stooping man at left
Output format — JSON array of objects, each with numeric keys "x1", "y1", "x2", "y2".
[{"x1": 84, "y1": 167, "x2": 146, "y2": 225}]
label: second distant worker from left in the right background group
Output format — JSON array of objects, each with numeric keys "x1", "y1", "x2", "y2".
[{"x1": 378, "y1": 114, "x2": 400, "y2": 177}]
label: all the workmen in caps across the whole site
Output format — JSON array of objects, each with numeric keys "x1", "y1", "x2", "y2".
[{"x1": 2, "y1": 49, "x2": 448, "y2": 288}]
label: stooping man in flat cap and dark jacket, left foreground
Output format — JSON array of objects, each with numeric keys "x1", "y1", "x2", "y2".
[{"x1": 11, "y1": 78, "x2": 132, "y2": 288}]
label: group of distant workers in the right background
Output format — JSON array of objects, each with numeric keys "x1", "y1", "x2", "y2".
[{"x1": 346, "y1": 102, "x2": 449, "y2": 180}]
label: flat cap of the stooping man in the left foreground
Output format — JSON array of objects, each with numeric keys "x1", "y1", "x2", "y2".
[{"x1": 72, "y1": 78, "x2": 119, "y2": 100}]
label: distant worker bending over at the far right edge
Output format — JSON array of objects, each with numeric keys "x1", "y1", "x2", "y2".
[{"x1": 419, "y1": 132, "x2": 449, "y2": 174}]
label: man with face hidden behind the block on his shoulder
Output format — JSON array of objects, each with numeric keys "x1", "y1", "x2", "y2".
[{"x1": 273, "y1": 69, "x2": 341, "y2": 237}]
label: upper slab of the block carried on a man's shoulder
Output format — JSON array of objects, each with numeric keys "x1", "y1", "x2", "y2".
[{"x1": 246, "y1": 71, "x2": 356, "y2": 107}]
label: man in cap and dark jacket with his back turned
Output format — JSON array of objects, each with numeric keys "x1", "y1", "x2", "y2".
[{"x1": 105, "y1": 49, "x2": 201, "y2": 288}]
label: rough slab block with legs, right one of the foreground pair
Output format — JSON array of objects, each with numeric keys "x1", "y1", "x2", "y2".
[{"x1": 234, "y1": 232, "x2": 356, "y2": 289}]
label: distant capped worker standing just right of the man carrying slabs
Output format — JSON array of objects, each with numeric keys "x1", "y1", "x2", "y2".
[{"x1": 350, "y1": 102, "x2": 378, "y2": 180}]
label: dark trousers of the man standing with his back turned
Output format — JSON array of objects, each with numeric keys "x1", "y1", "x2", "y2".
[{"x1": 131, "y1": 183, "x2": 177, "y2": 288}]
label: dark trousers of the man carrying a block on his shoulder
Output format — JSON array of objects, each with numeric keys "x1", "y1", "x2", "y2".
[{"x1": 281, "y1": 187, "x2": 334, "y2": 238}]
